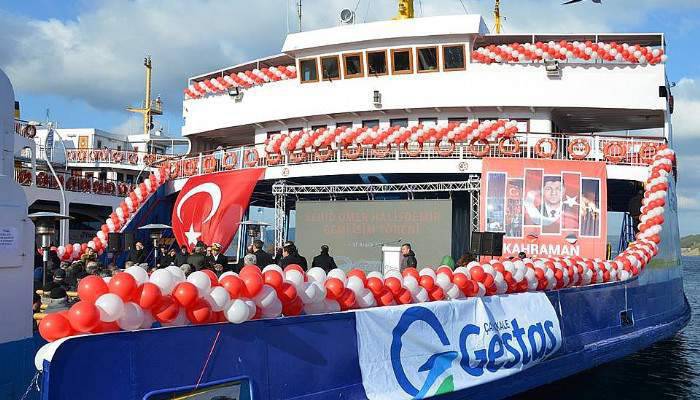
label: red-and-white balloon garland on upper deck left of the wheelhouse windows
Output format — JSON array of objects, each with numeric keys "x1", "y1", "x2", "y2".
[{"x1": 184, "y1": 65, "x2": 297, "y2": 99}]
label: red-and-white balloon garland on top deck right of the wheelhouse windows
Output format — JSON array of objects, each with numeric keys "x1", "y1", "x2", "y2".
[{"x1": 472, "y1": 40, "x2": 668, "y2": 65}]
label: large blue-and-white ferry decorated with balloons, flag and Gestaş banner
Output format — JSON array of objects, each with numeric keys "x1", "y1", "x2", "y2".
[{"x1": 0, "y1": 1, "x2": 690, "y2": 399}]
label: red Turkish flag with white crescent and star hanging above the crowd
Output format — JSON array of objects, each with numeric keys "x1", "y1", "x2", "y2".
[{"x1": 172, "y1": 168, "x2": 265, "y2": 253}]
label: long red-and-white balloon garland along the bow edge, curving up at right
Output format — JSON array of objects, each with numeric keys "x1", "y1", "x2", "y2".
[{"x1": 39, "y1": 148, "x2": 675, "y2": 341}]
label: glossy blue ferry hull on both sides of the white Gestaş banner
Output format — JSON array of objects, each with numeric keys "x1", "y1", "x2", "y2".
[{"x1": 42, "y1": 267, "x2": 690, "y2": 400}]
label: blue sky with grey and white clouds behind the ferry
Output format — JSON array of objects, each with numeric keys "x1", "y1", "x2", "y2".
[{"x1": 0, "y1": 0, "x2": 700, "y2": 234}]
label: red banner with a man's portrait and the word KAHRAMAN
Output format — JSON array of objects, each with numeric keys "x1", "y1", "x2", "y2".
[{"x1": 480, "y1": 158, "x2": 607, "y2": 257}]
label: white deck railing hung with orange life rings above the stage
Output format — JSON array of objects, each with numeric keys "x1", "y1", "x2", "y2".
[{"x1": 166, "y1": 133, "x2": 666, "y2": 177}]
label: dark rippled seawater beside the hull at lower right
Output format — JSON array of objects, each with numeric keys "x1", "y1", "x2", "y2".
[{"x1": 510, "y1": 257, "x2": 700, "y2": 400}]
